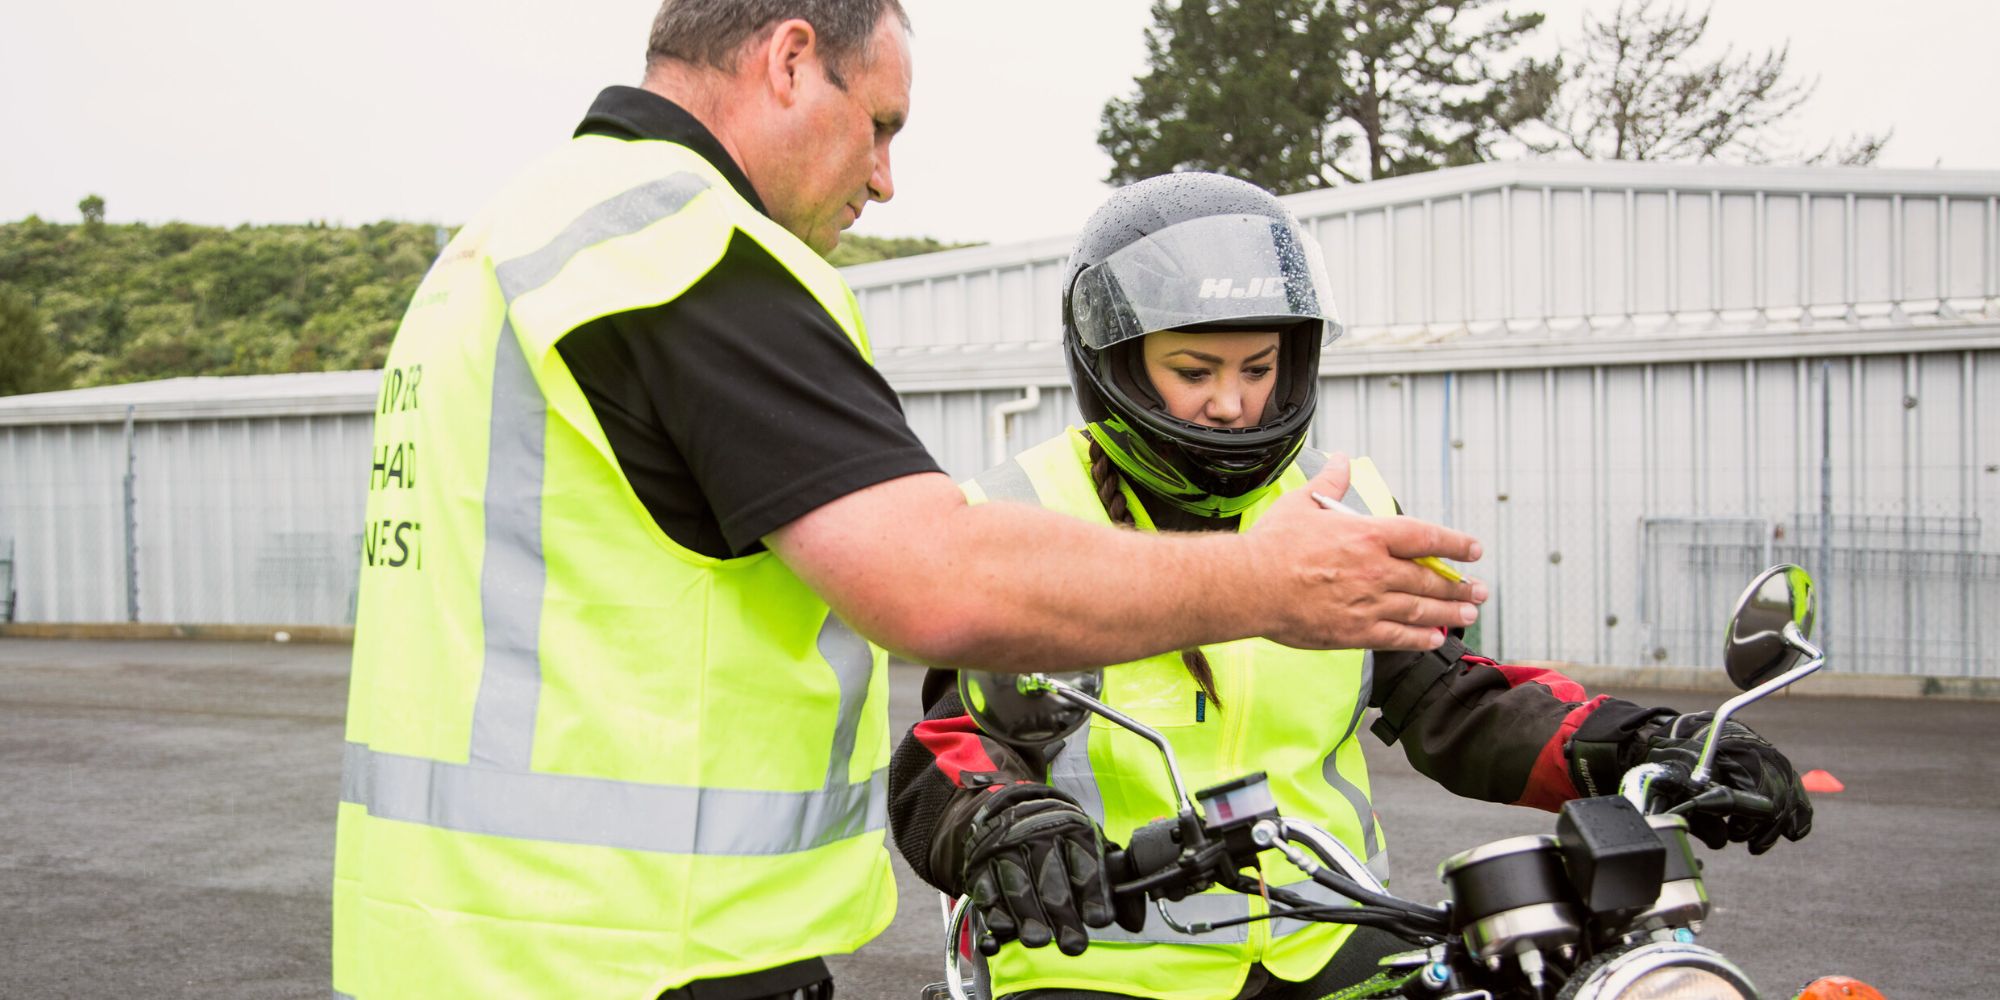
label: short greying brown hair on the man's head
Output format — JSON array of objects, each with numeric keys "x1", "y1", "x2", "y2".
[{"x1": 646, "y1": 0, "x2": 910, "y2": 90}]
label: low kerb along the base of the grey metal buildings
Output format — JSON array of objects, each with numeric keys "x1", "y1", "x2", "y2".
[{"x1": 0, "y1": 622, "x2": 2000, "y2": 702}]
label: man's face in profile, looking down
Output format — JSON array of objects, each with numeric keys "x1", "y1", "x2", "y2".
[{"x1": 760, "y1": 14, "x2": 910, "y2": 254}]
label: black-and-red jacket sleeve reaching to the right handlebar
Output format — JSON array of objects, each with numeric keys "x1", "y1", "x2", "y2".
[{"x1": 1368, "y1": 636, "x2": 1674, "y2": 812}]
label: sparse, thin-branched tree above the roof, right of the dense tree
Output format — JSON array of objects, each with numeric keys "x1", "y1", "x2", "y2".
[{"x1": 1532, "y1": 0, "x2": 1890, "y2": 166}]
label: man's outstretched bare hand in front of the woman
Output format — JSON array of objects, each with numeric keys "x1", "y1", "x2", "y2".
[{"x1": 1250, "y1": 452, "x2": 1488, "y2": 650}]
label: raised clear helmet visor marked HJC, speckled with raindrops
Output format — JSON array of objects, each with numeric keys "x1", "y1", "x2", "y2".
[{"x1": 1070, "y1": 214, "x2": 1340, "y2": 350}]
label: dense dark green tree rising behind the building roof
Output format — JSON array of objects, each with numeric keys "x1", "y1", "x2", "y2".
[{"x1": 1098, "y1": 0, "x2": 1558, "y2": 194}]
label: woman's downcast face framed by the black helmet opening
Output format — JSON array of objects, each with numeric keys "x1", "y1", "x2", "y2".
[{"x1": 1144, "y1": 330, "x2": 1280, "y2": 428}]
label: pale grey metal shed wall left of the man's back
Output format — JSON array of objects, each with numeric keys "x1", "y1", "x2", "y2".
[{"x1": 0, "y1": 412, "x2": 368, "y2": 624}]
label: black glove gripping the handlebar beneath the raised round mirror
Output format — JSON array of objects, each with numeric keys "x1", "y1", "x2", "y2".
[{"x1": 1638, "y1": 712, "x2": 1812, "y2": 854}]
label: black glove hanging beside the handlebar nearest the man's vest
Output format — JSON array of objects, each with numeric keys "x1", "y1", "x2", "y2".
[{"x1": 958, "y1": 782, "x2": 1112, "y2": 956}]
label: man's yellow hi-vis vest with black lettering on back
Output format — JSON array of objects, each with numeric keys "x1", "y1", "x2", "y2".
[{"x1": 332, "y1": 136, "x2": 896, "y2": 1000}]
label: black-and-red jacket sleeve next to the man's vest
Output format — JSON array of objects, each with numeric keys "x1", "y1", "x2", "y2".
[{"x1": 888, "y1": 670, "x2": 1060, "y2": 894}]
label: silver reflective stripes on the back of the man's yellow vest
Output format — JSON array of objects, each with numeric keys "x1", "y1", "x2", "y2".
[{"x1": 342, "y1": 174, "x2": 888, "y2": 854}]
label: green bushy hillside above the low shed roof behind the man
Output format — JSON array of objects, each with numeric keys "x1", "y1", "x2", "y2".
[{"x1": 0, "y1": 218, "x2": 968, "y2": 392}]
